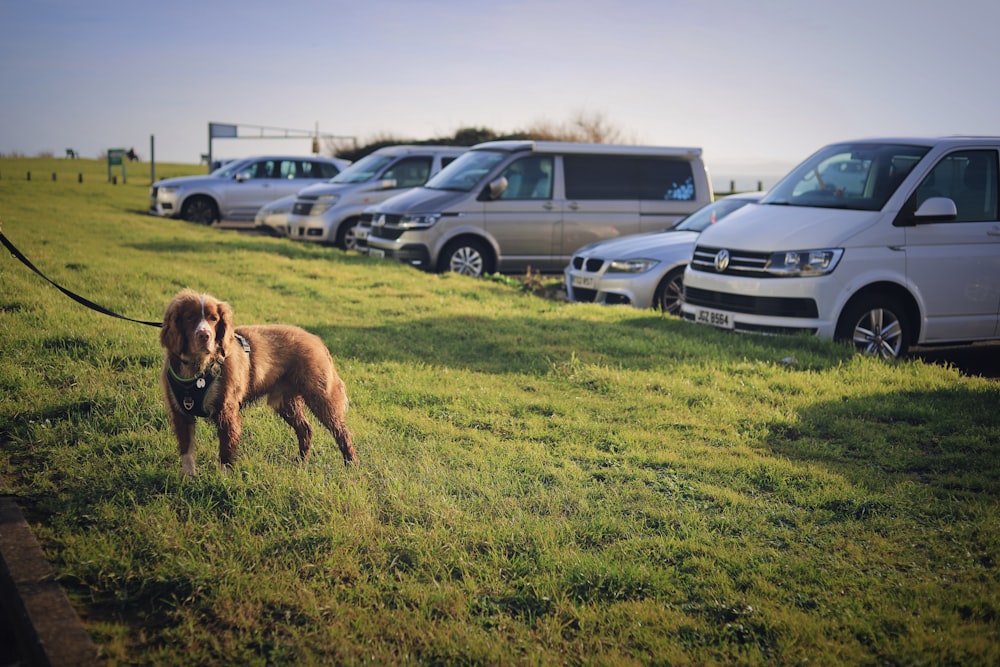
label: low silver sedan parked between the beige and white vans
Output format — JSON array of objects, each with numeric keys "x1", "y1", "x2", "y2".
[{"x1": 563, "y1": 192, "x2": 764, "y2": 315}]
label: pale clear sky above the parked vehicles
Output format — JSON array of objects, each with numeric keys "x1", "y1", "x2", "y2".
[{"x1": 0, "y1": 0, "x2": 1000, "y2": 188}]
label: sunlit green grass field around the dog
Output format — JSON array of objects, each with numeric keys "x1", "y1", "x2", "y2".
[{"x1": 0, "y1": 159, "x2": 1000, "y2": 665}]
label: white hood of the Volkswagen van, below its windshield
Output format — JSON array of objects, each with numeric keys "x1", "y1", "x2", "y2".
[{"x1": 698, "y1": 204, "x2": 881, "y2": 252}]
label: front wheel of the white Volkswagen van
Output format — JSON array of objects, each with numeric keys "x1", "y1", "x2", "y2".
[{"x1": 835, "y1": 294, "x2": 912, "y2": 359}]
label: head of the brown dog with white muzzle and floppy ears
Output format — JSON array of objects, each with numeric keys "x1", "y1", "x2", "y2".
[{"x1": 160, "y1": 289, "x2": 233, "y2": 357}]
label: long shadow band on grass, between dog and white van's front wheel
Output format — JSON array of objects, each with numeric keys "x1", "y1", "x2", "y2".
[{"x1": 311, "y1": 315, "x2": 851, "y2": 374}]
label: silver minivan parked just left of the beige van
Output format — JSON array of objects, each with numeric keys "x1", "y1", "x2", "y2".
[{"x1": 282, "y1": 146, "x2": 467, "y2": 250}]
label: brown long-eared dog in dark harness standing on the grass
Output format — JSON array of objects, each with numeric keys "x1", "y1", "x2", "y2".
[{"x1": 160, "y1": 289, "x2": 357, "y2": 475}]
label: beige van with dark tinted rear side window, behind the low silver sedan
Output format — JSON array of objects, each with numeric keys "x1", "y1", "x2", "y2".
[{"x1": 368, "y1": 141, "x2": 712, "y2": 276}]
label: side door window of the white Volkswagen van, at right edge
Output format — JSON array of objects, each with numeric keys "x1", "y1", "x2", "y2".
[{"x1": 913, "y1": 150, "x2": 997, "y2": 222}]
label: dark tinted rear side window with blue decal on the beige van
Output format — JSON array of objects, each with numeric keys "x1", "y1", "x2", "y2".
[{"x1": 563, "y1": 155, "x2": 695, "y2": 201}]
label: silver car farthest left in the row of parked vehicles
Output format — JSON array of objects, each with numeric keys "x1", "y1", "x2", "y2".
[{"x1": 149, "y1": 155, "x2": 350, "y2": 224}]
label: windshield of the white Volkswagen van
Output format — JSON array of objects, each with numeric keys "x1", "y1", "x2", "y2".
[{"x1": 761, "y1": 143, "x2": 930, "y2": 211}]
